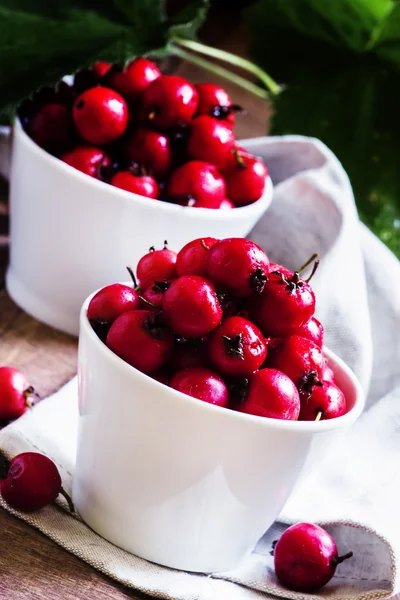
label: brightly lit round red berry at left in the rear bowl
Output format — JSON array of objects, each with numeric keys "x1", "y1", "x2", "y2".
[{"x1": 72, "y1": 86, "x2": 129, "y2": 145}]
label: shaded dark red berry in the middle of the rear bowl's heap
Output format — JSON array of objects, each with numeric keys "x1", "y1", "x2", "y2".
[{"x1": 125, "y1": 128, "x2": 172, "y2": 177}]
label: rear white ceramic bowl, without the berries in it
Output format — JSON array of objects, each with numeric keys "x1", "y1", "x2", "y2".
[{"x1": 6, "y1": 121, "x2": 272, "y2": 335}]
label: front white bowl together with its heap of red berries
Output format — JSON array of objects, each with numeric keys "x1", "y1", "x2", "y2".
[{"x1": 73, "y1": 236, "x2": 364, "y2": 573}]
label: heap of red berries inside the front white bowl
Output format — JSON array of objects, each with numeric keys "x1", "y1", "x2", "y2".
[{"x1": 87, "y1": 237, "x2": 347, "y2": 421}]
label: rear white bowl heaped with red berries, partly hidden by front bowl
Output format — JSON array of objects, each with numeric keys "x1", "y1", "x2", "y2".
[{"x1": 6, "y1": 58, "x2": 272, "y2": 335}]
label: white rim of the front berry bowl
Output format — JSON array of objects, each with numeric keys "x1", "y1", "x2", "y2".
[{"x1": 78, "y1": 282, "x2": 365, "y2": 434}]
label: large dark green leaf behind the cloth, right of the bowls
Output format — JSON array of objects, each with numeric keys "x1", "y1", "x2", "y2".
[{"x1": 247, "y1": 0, "x2": 400, "y2": 257}]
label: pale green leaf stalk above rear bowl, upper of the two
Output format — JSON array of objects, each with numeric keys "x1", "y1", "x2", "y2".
[{"x1": 172, "y1": 37, "x2": 282, "y2": 96}]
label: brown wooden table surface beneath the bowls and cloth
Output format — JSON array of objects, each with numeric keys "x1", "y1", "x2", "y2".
[{"x1": 0, "y1": 16, "x2": 269, "y2": 600}]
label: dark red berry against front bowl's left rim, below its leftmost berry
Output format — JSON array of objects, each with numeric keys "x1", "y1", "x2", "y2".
[{"x1": 106, "y1": 310, "x2": 174, "y2": 374}]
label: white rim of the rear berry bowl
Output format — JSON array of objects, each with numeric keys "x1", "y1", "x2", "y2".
[{"x1": 13, "y1": 117, "x2": 273, "y2": 221}]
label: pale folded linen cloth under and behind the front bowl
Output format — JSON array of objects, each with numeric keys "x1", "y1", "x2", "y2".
[{"x1": 0, "y1": 136, "x2": 400, "y2": 600}]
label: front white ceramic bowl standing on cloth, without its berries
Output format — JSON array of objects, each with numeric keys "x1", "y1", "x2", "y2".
[{"x1": 73, "y1": 298, "x2": 364, "y2": 573}]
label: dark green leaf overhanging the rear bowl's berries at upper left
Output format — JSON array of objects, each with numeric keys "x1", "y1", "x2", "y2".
[{"x1": 0, "y1": 0, "x2": 208, "y2": 123}]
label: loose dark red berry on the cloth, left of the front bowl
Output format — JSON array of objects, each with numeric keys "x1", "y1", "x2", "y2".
[{"x1": 0, "y1": 452, "x2": 62, "y2": 512}]
